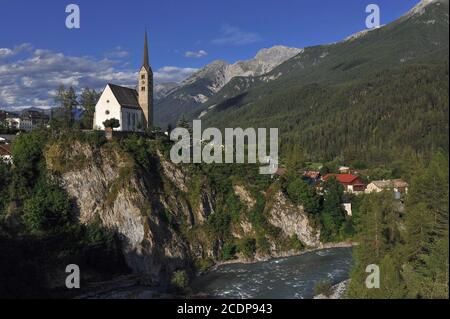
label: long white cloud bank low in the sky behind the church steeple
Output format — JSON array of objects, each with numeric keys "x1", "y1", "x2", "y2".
[{"x1": 0, "y1": 45, "x2": 197, "y2": 108}]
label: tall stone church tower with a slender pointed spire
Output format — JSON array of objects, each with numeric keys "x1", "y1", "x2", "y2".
[{"x1": 137, "y1": 31, "x2": 153, "y2": 128}]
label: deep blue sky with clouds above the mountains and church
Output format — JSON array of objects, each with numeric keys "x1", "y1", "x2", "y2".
[{"x1": 0, "y1": 0, "x2": 419, "y2": 107}]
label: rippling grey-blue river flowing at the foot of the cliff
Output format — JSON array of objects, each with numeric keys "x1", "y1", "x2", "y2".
[{"x1": 192, "y1": 248, "x2": 352, "y2": 299}]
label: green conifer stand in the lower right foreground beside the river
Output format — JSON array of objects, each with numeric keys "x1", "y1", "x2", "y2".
[{"x1": 348, "y1": 153, "x2": 449, "y2": 299}]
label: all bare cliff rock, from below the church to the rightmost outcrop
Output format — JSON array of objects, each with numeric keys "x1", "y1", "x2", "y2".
[{"x1": 46, "y1": 142, "x2": 319, "y2": 283}]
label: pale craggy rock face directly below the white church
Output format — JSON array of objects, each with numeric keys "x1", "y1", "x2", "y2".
[{"x1": 47, "y1": 143, "x2": 200, "y2": 281}]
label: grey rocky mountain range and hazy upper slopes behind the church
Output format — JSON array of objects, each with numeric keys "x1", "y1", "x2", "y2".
[{"x1": 155, "y1": 0, "x2": 449, "y2": 131}]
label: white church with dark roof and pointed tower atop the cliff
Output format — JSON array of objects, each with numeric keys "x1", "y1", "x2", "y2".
[{"x1": 94, "y1": 32, "x2": 153, "y2": 132}]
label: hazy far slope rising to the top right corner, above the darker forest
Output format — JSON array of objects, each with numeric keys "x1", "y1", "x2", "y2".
[{"x1": 192, "y1": 0, "x2": 449, "y2": 122}]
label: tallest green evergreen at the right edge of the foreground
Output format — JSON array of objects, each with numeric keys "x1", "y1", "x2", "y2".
[{"x1": 404, "y1": 154, "x2": 449, "y2": 298}]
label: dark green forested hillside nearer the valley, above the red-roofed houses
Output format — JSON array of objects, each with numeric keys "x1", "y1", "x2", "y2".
[{"x1": 205, "y1": 63, "x2": 449, "y2": 169}]
